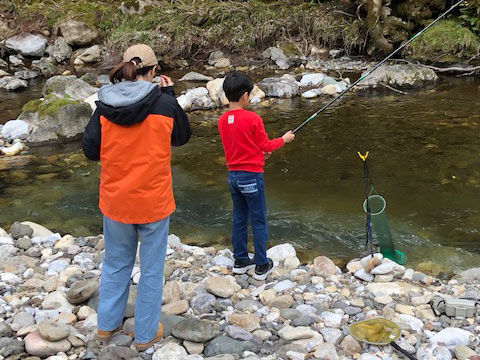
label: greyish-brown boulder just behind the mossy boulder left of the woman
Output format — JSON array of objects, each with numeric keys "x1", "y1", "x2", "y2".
[{"x1": 43, "y1": 75, "x2": 98, "y2": 101}]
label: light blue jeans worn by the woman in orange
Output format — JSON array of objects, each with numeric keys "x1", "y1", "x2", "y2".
[{"x1": 98, "y1": 216, "x2": 170, "y2": 343}]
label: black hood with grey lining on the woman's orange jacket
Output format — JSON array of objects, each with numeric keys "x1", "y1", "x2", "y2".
[{"x1": 97, "y1": 81, "x2": 162, "y2": 126}]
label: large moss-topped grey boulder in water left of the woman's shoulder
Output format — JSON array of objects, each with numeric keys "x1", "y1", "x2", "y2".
[{"x1": 18, "y1": 96, "x2": 92, "y2": 144}]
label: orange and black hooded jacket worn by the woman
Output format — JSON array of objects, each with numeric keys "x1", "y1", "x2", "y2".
[{"x1": 82, "y1": 81, "x2": 191, "y2": 224}]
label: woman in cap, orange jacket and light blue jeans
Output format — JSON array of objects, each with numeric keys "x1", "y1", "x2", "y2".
[{"x1": 82, "y1": 45, "x2": 191, "y2": 351}]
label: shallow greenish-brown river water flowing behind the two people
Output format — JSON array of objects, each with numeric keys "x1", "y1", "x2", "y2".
[{"x1": 0, "y1": 74, "x2": 480, "y2": 274}]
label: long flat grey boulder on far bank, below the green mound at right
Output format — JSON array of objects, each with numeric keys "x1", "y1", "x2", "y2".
[{"x1": 360, "y1": 64, "x2": 438, "y2": 88}]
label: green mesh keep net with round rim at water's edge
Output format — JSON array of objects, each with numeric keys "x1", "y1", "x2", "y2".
[{"x1": 363, "y1": 194, "x2": 407, "y2": 264}]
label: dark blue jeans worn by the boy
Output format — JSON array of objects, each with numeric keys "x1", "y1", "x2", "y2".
[{"x1": 228, "y1": 171, "x2": 268, "y2": 265}]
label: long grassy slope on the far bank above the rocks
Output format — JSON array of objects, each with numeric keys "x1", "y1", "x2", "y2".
[{"x1": 4, "y1": 0, "x2": 366, "y2": 58}]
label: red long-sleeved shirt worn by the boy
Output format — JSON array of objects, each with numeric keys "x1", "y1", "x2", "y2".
[{"x1": 218, "y1": 109, "x2": 284, "y2": 173}]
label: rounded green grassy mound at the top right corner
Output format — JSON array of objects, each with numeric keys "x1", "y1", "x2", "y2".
[{"x1": 406, "y1": 20, "x2": 480, "y2": 63}]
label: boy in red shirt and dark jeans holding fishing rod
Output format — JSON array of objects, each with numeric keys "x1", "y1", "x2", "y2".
[{"x1": 218, "y1": 71, "x2": 295, "y2": 280}]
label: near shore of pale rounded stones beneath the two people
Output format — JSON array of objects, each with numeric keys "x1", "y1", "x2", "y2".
[{"x1": 0, "y1": 222, "x2": 480, "y2": 360}]
